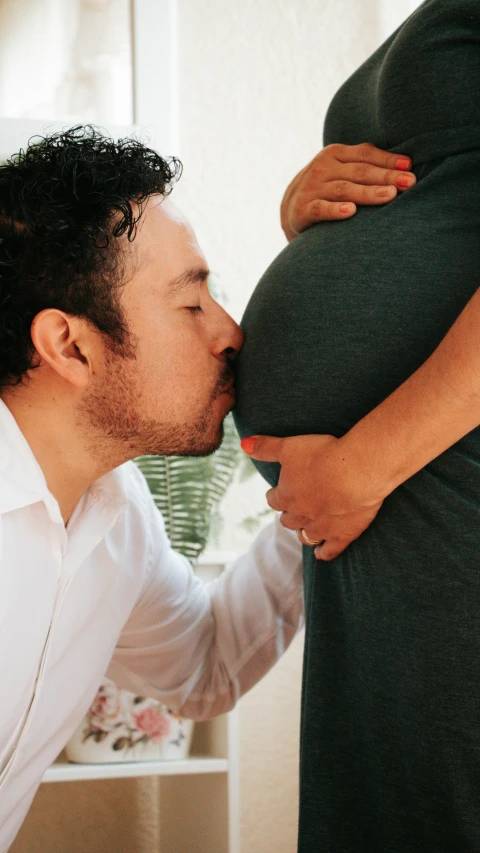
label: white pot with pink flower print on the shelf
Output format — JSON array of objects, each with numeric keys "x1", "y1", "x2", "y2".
[{"x1": 65, "y1": 678, "x2": 193, "y2": 764}]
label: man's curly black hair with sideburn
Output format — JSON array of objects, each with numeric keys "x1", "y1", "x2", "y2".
[{"x1": 0, "y1": 125, "x2": 182, "y2": 389}]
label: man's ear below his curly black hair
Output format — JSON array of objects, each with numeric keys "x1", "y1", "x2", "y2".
[{"x1": 30, "y1": 308, "x2": 94, "y2": 388}]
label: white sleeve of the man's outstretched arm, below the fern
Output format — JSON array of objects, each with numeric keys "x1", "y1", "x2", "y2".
[{"x1": 107, "y1": 496, "x2": 304, "y2": 719}]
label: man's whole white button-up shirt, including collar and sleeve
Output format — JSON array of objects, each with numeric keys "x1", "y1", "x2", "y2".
[{"x1": 0, "y1": 400, "x2": 303, "y2": 853}]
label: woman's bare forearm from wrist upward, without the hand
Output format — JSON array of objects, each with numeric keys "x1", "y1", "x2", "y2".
[{"x1": 342, "y1": 289, "x2": 480, "y2": 497}]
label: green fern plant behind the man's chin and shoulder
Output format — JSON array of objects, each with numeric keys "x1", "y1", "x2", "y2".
[{"x1": 135, "y1": 415, "x2": 243, "y2": 563}]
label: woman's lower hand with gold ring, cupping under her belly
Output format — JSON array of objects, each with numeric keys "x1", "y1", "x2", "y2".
[{"x1": 241, "y1": 435, "x2": 388, "y2": 560}]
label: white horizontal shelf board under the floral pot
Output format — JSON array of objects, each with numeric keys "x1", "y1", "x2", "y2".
[{"x1": 42, "y1": 753, "x2": 228, "y2": 782}]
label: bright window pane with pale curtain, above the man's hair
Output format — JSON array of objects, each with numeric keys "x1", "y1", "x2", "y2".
[{"x1": 0, "y1": 0, "x2": 133, "y2": 124}]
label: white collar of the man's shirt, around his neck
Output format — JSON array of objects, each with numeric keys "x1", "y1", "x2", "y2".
[{"x1": 0, "y1": 399, "x2": 128, "y2": 524}]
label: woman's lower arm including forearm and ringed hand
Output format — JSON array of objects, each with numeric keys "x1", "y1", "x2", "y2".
[{"x1": 242, "y1": 290, "x2": 480, "y2": 560}]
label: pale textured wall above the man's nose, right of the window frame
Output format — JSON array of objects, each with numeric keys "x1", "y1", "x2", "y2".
[{"x1": 175, "y1": 0, "x2": 377, "y2": 318}]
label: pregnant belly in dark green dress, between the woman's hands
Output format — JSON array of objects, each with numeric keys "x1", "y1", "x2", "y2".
[{"x1": 235, "y1": 176, "x2": 480, "y2": 450}]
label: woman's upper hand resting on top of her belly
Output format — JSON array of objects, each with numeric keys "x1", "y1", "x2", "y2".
[{"x1": 280, "y1": 142, "x2": 416, "y2": 241}]
